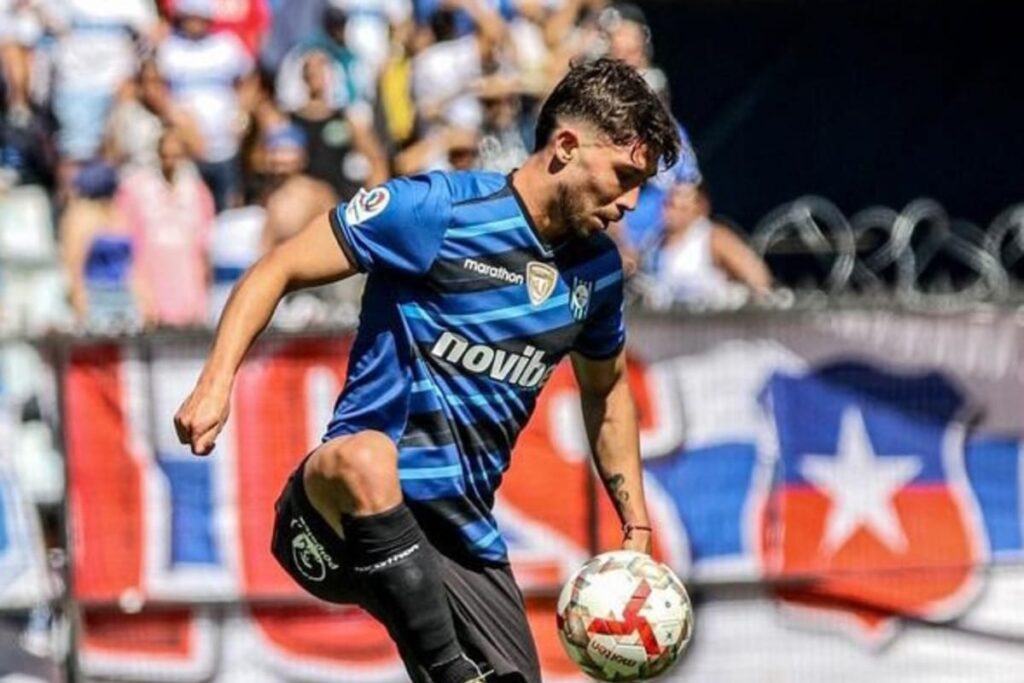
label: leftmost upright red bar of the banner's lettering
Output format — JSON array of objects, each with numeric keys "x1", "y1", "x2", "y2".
[{"x1": 63, "y1": 344, "x2": 143, "y2": 600}]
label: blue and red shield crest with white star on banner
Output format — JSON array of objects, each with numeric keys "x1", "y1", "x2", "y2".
[{"x1": 762, "y1": 362, "x2": 984, "y2": 643}]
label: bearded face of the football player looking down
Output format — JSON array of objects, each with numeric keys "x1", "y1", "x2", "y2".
[{"x1": 557, "y1": 133, "x2": 656, "y2": 238}]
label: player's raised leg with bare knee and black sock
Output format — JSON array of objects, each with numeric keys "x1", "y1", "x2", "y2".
[{"x1": 303, "y1": 431, "x2": 479, "y2": 683}]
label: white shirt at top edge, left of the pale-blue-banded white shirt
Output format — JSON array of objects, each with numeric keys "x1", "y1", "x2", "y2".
[{"x1": 44, "y1": 0, "x2": 157, "y2": 90}]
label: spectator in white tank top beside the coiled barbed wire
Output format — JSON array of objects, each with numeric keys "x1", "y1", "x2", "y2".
[{"x1": 646, "y1": 183, "x2": 771, "y2": 307}]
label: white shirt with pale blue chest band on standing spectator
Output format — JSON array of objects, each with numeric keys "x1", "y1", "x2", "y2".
[{"x1": 157, "y1": 31, "x2": 253, "y2": 162}]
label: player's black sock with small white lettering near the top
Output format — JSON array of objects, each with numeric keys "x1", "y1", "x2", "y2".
[{"x1": 341, "y1": 503, "x2": 475, "y2": 683}]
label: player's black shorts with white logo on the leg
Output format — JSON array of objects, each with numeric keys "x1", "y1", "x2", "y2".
[{"x1": 271, "y1": 461, "x2": 541, "y2": 683}]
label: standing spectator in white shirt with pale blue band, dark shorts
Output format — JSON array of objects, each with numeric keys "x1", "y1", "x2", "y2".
[{"x1": 157, "y1": 0, "x2": 255, "y2": 211}]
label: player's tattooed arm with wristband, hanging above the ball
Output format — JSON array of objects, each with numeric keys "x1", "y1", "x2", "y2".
[{"x1": 572, "y1": 351, "x2": 651, "y2": 553}]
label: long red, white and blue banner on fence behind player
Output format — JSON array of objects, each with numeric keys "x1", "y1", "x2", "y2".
[{"x1": 63, "y1": 310, "x2": 1024, "y2": 683}]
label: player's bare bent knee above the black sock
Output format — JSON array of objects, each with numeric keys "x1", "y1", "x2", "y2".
[{"x1": 305, "y1": 431, "x2": 401, "y2": 514}]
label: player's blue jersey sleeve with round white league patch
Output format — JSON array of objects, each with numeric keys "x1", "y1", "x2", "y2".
[{"x1": 331, "y1": 173, "x2": 452, "y2": 275}]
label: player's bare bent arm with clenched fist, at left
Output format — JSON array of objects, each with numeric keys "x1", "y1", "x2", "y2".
[{"x1": 174, "y1": 214, "x2": 356, "y2": 456}]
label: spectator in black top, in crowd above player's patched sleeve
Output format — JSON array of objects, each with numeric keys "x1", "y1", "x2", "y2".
[{"x1": 291, "y1": 50, "x2": 387, "y2": 201}]
